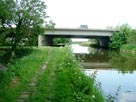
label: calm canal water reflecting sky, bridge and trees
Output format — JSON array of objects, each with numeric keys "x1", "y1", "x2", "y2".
[{"x1": 71, "y1": 44, "x2": 136, "y2": 102}]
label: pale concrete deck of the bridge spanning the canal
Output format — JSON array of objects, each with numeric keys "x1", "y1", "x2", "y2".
[{"x1": 45, "y1": 28, "x2": 115, "y2": 37}]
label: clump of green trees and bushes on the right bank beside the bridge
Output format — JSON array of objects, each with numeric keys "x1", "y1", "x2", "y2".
[{"x1": 109, "y1": 24, "x2": 136, "y2": 50}]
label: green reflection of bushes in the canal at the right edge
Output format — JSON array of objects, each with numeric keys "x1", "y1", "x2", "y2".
[{"x1": 109, "y1": 52, "x2": 136, "y2": 73}]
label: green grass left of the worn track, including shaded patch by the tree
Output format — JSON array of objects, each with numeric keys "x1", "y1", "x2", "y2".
[{"x1": 0, "y1": 48, "x2": 48, "y2": 102}]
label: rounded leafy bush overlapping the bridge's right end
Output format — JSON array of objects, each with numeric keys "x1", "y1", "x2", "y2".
[{"x1": 109, "y1": 24, "x2": 131, "y2": 50}]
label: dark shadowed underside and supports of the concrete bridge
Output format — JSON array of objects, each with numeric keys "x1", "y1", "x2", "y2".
[{"x1": 38, "y1": 35, "x2": 109, "y2": 47}]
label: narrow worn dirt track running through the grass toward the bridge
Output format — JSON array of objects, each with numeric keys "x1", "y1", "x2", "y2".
[{"x1": 17, "y1": 48, "x2": 53, "y2": 102}]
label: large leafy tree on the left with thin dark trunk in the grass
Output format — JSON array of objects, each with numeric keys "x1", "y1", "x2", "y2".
[{"x1": 0, "y1": 0, "x2": 54, "y2": 55}]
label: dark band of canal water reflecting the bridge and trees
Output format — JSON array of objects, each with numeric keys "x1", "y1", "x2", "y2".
[{"x1": 72, "y1": 45, "x2": 136, "y2": 73}]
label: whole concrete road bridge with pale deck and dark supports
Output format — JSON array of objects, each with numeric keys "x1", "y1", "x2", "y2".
[{"x1": 38, "y1": 28, "x2": 115, "y2": 47}]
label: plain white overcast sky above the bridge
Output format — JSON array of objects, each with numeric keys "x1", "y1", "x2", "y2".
[{"x1": 45, "y1": 0, "x2": 136, "y2": 29}]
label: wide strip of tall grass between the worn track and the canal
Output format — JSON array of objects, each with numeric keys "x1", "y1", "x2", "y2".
[{"x1": 27, "y1": 48, "x2": 104, "y2": 102}]
